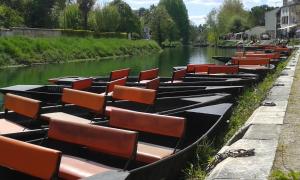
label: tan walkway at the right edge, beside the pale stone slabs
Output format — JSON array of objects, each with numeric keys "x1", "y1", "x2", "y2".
[{"x1": 273, "y1": 47, "x2": 300, "y2": 172}]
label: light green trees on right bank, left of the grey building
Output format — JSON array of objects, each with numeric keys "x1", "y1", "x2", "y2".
[{"x1": 199, "y1": 0, "x2": 274, "y2": 44}]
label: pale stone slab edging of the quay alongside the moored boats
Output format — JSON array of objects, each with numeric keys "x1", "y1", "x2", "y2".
[{"x1": 207, "y1": 47, "x2": 300, "y2": 179}]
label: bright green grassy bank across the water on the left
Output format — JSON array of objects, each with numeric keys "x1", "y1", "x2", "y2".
[{"x1": 0, "y1": 37, "x2": 161, "y2": 66}]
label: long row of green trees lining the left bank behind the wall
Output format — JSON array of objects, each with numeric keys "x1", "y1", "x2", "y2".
[{"x1": 0, "y1": 0, "x2": 193, "y2": 44}]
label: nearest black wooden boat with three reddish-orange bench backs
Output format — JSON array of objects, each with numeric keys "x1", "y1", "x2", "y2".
[{"x1": 0, "y1": 103, "x2": 232, "y2": 179}]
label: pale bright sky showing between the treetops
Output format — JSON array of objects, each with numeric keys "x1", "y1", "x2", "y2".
[{"x1": 98, "y1": 0, "x2": 282, "y2": 25}]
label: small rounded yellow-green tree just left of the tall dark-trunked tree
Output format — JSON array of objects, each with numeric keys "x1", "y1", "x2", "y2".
[{"x1": 59, "y1": 4, "x2": 82, "y2": 29}]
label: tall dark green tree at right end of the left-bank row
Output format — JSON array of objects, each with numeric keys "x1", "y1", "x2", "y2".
[{"x1": 159, "y1": 0, "x2": 190, "y2": 43}]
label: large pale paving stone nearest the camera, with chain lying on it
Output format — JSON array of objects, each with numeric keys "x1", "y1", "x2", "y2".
[{"x1": 207, "y1": 139, "x2": 277, "y2": 180}]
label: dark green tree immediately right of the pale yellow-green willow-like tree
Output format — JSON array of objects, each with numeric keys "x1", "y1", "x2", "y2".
[{"x1": 109, "y1": 0, "x2": 141, "y2": 33}]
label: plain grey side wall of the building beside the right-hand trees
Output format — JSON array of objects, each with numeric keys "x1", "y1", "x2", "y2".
[{"x1": 265, "y1": 8, "x2": 280, "y2": 39}]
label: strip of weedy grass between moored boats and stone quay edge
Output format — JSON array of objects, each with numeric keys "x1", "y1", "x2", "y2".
[{"x1": 184, "y1": 59, "x2": 287, "y2": 179}]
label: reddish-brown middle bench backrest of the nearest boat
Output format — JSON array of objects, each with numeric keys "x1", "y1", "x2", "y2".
[{"x1": 48, "y1": 119, "x2": 138, "y2": 159}]
